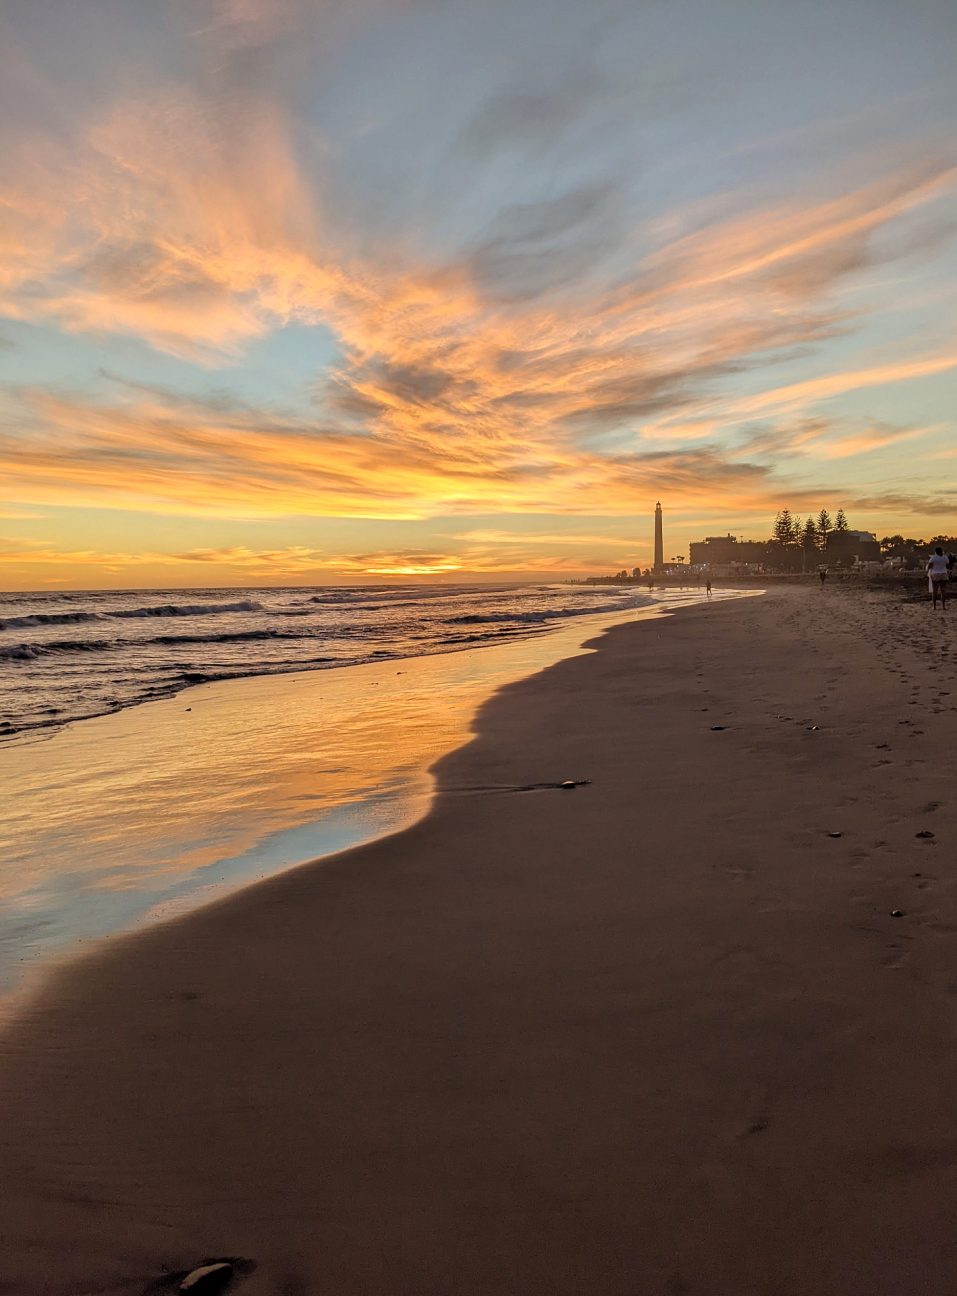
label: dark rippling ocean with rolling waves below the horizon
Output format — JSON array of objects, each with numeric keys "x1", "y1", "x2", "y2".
[{"x1": 0, "y1": 584, "x2": 652, "y2": 741}]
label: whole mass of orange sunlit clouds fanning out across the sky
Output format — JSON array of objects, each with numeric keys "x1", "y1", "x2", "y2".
[{"x1": 0, "y1": 34, "x2": 957, "y2": 544}]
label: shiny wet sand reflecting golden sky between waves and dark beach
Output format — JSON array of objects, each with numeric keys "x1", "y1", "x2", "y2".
[{"x1": 0, "y1": 595, "x2": 741, "y2": 991}]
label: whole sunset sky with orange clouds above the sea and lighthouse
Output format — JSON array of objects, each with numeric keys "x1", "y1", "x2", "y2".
[{"x1": 0, "y1": 0, "x2": 957, "y2": 588}]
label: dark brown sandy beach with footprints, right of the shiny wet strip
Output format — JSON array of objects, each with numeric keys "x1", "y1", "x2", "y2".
[{"x1": 0, "y1": 588, "x2": 957, "y2": 1296}]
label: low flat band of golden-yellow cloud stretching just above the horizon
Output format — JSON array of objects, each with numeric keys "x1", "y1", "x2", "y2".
[{"x1": 0, "y1": 378, "x2": 819, "y2": 518}]
